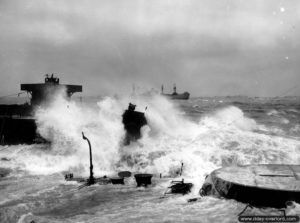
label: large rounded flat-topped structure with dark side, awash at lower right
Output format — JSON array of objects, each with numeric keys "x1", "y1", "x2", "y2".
[{"x1": 200, "y1": 164, "x2": 300, "y2": 208}]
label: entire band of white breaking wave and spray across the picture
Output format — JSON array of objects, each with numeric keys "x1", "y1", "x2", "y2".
[{"x1": 1, "y1": 94, "x2": 300, "y2": 187}]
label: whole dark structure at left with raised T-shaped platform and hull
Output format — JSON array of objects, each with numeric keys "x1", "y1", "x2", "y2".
[{"x1": 0, "y1": 74, "x2": 82, "y2": 145}]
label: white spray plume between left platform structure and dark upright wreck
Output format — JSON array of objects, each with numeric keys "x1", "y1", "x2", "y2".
[{"x1": 36, "y1": 92, "x2": 124, "y2": 174}]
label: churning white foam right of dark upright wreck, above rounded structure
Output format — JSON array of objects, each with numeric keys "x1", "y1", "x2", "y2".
[{"x1": 122, "y1": 106, "x2": 299, "y2": 185}]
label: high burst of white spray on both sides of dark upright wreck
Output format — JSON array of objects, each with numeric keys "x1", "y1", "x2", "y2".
[{"x1": 32, "y1": 95, "x2": 196, "y2": 178}]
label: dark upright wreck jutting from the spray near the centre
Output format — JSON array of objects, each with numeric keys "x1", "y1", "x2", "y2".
[{"x1": 122, "y1": 103, "x2": 147, "y2": 145}]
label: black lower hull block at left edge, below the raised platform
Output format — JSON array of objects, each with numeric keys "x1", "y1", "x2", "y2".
[{"x1": 0, "y1": 117, "x2": 38, "y2": 145}]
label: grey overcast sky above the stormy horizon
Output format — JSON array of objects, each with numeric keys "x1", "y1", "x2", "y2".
[{"x1": 0, "y1": 0, "x2": 300, "y2": 96}]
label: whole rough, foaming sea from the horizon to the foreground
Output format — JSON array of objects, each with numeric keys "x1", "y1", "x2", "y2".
[{"x1": 0, "y1": 96, "x2": 300, "y2": 223}]
